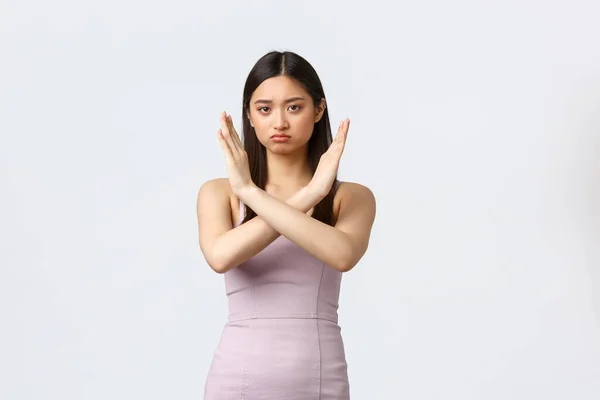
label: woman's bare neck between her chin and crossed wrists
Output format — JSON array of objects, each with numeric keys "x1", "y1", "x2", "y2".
[{"x1": 267, "y1": 150, "x2": 312, "y2": 188}]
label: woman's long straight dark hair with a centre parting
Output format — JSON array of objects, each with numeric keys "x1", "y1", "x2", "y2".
[{"x1": 242, "y1": 51, "x2": 339, "y2": 225}]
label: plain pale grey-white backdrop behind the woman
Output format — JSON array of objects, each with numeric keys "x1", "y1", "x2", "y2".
[{"x1": 0, "y1": 0, "x2": 600, "y2": 400}]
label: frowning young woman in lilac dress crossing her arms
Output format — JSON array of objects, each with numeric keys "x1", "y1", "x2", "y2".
[{"x1": 197, "y1": 52, "x2": 375, "y2": 400}]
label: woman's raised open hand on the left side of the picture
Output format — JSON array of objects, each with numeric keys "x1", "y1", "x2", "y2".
[{"x1": 217, "y1": 112, "x2": 255, "y2": 197}]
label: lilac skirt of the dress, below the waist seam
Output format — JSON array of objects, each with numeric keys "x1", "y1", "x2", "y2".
[{"x1": 204, "y1": 318, "x2": 349, "y2": 400}]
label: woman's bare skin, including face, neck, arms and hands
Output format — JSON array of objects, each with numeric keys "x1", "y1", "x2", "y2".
[{"x1": 197, "y1": 76, "x2": 376, "y2": 273}]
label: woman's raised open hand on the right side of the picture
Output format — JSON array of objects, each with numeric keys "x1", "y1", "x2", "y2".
[{"x1": 310, "y1": 118, "x2": 350, "y2": 197}]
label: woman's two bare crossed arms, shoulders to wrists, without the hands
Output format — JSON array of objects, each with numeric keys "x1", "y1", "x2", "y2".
[{"x1": 197, "y1": 179, "x2": 376, "y2": 273}]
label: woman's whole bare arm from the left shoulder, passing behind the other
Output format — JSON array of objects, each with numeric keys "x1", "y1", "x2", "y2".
[{"x1": 197, "y1": 180, "x2": 320, "y2": 273}]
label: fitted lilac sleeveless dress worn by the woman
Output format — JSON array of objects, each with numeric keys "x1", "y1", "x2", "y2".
[{"x1": 204, "y1": 195, "x2": 350, "y2": 400}]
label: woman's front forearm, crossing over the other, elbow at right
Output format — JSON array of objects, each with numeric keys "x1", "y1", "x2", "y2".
[{"x1": 240, "y1": 186, "x2": 354, "y2": 271}]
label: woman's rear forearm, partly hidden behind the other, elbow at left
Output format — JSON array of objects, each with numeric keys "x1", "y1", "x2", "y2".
[{"x1": 212, "y1": 188, "x2": 320, "y2": 273}]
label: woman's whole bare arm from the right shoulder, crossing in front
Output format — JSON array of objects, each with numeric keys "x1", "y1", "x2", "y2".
[{"x1": 240, "y1": 183, "x2": 375, "y2": 272}]
